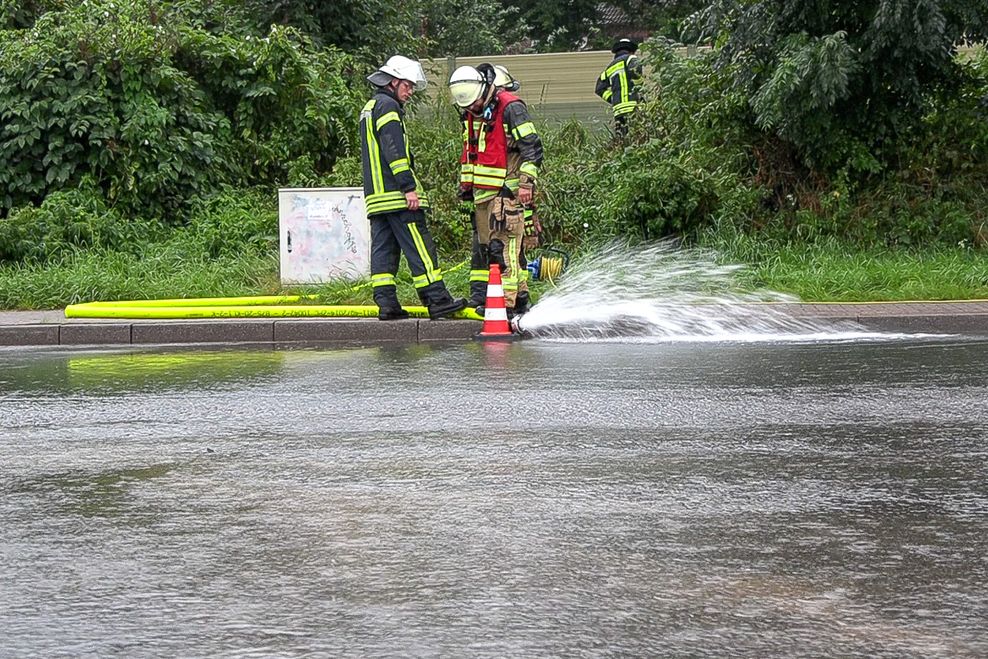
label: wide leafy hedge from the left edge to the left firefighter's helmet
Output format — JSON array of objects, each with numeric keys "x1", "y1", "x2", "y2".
[{"x1": 0, "y1": 0, "x2": 360, "y2": 221}]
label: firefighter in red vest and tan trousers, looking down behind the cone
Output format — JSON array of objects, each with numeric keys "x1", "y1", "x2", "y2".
[{"x1": 449, "y1": 64, "x2": 542, "y2": 314}]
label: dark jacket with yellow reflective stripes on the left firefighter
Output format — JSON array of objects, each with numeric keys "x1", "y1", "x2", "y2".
[{"x1": 360, "y1": 87, "x2": 429, "y2": 216}]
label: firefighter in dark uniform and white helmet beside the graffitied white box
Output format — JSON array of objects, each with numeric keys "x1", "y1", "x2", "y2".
[{"x1": 360, "y1": 55, "x2": 466, "y2": 320}]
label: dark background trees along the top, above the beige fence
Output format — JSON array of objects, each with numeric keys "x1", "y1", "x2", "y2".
[{"x1": 170, "y1": 0, "x2": 705, "y2": 56}]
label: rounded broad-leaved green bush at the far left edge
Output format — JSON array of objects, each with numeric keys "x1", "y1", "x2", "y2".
[{"x1": 0, "y1": 3, "x2": 235, "y2": 215}]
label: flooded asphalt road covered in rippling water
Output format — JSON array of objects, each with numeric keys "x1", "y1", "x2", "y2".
[{"x1": 0, "y1": 338, "x2": 988, "y2": 657}]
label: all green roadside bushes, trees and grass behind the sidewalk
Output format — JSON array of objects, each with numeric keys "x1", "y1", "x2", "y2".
[{"x1": 0, "y1": 0, "x2": 988, "y2": 309}]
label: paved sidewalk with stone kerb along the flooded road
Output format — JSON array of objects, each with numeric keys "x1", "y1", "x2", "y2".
[{"x1": 0, "y1": 300, "x2": 988, "y2": 346}]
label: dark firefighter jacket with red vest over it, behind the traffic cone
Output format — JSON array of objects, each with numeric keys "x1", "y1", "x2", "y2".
[{"x1": 460, "y1": 90, "x2": 542, "y2": 202}]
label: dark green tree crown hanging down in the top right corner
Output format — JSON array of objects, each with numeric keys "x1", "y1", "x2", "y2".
[{"x1": 695, "y1": 0, "x2": 988, "y2": 177}]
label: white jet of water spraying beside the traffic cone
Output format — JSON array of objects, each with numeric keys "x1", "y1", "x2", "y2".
[{"x1": 518, "y1": 241, "x2": 875, "y2": 341}]
